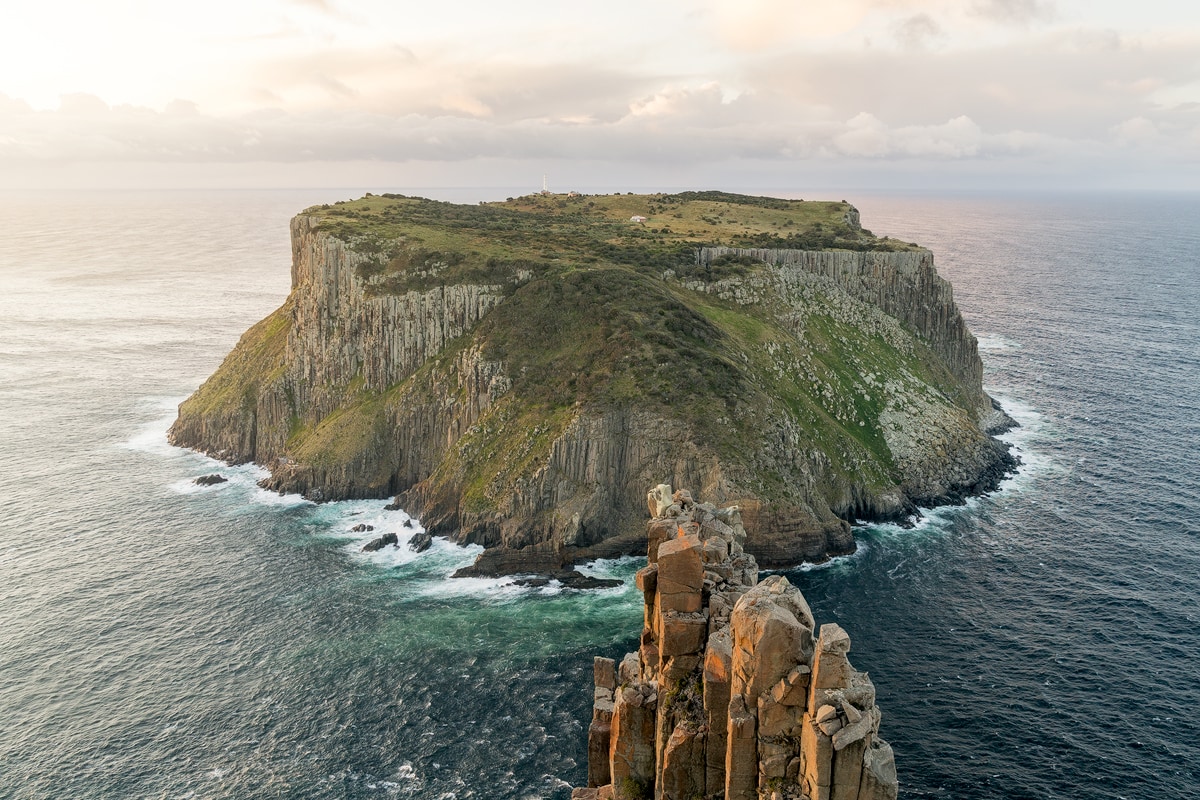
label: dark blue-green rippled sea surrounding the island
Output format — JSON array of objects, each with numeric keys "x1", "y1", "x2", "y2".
[{"x1": 0, "y1": 187, "x2": 1200, "y2": 800}]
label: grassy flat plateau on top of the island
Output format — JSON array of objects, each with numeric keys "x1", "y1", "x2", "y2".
[{"x1": 305, "y1": 192, "x2": 913, "y2": 293}]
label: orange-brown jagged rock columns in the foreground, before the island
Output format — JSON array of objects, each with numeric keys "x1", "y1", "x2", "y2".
[{"x1": 571, "y1": 486, "x2": 898, "y2": 800}]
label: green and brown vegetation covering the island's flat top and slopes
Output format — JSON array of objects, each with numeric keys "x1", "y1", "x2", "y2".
[{"x1": 177, "y1": 192, "x2": 979, "y2": 525}]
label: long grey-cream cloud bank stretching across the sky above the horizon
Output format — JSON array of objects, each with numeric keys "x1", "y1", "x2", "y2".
[{"x1": 0, "y1": 32, "x2": 1200, "y2": 178}]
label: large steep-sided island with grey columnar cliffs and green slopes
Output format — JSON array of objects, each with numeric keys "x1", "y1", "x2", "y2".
[{"x1": 170, "y1": 196, "x2": 1009, "y2": 573}]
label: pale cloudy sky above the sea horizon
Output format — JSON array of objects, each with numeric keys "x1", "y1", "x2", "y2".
[{"x1": 0, "y1": 0, "x2": 1200, "y2": 191}]
